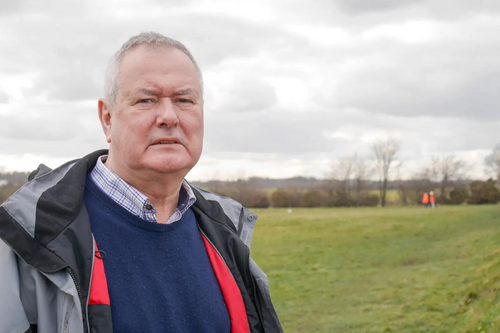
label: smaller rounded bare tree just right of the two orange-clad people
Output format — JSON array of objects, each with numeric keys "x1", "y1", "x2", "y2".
[{"x1": 430, "y1": 155, "x2": 470, "y2": 204}]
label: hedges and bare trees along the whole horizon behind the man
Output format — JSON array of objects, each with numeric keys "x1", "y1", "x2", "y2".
[{"x1": 0, "y1": 138, "x2": 500, "y2": 208}]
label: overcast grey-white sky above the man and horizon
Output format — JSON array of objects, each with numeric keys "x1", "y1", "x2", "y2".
[{"x1": 0, "y1": 0, "x2": 500, "y2": 180}]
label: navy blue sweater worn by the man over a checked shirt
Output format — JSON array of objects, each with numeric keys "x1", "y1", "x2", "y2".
[{"x1": 85, "y1": 177, "x2": 231, "y2": 333}]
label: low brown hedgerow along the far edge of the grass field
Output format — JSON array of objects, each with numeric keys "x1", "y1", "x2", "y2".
[{"x1": 206, "y1": 179, "x2": 500, "y2": 208}]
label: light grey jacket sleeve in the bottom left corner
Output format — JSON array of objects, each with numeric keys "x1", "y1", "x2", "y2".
[{"x1": 0, "y1": 239, "x2": 30, "y2": 333}]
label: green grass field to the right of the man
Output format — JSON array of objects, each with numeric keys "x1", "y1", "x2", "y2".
[{"x1": 252, "y1": 205, "x2": 500, "y2": 333}]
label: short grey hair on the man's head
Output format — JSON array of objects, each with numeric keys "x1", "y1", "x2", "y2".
[{"x1": 104, "y1": 32, "x2": 203, "y2": 106}]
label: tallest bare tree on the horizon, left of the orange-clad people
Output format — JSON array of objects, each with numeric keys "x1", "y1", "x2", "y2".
[{"x1": 372, "y1": 138, "x2": 401, "y2": 207}]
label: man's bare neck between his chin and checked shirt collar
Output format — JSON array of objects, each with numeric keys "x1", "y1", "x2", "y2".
[{"x1": 104, "y1": 156, "x2": 184, "y2": 223}]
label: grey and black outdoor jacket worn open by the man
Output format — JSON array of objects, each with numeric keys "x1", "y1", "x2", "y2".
[{"x1": 0, "y1": 151, "x2": 283, "y2": 333}]
